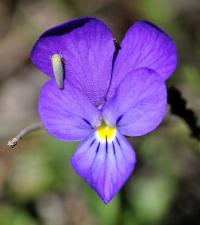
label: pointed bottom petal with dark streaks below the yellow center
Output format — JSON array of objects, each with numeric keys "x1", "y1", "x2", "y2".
[{"x1": 71, "y1": 132, "x2": 136, "y2": 204}]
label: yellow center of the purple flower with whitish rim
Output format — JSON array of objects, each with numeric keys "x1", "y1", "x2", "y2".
[{"x1": 96, "y1": 121, "x2": 116, "y2": 142}]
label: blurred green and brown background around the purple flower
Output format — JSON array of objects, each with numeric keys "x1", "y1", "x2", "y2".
[{"x1": 0, "y1": 0, "x2": 200, "y2": 225}]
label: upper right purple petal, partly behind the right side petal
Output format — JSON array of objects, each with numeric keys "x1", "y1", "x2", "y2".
[{"x1": 110, "y1": 21, "x2": 177, "y2": 95}]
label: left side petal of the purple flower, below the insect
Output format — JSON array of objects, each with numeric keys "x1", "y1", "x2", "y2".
[{"x1": 39, "y1": 80, "x2": 101, "y2": 141}]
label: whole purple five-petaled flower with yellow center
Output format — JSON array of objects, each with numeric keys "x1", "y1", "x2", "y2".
[{"x1": 31, "y1": 17, "x2": 177, "y2": 203}]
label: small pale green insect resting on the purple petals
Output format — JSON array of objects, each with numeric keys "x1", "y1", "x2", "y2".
[{"x1": 51, "y1": 54, "x2": 64, "y2": 89}]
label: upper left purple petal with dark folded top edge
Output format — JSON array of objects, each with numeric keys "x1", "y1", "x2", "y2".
[{"x1": 31, "y1": 17, "x2": 115, "y2": 105}]
